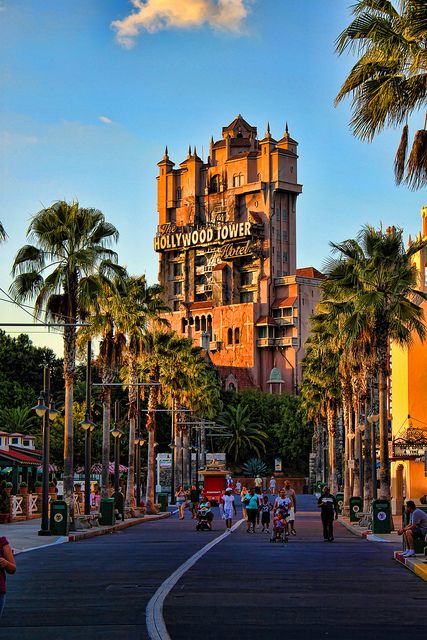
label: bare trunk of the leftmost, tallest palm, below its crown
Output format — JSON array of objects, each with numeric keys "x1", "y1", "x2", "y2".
[{"x1": 64, "y1": 326, "x2": 76, "y2": 514}]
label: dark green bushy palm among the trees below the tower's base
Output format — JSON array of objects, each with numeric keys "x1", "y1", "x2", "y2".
[{"x1": 217, "y1": 403, "x2": 268, "y2": 462}]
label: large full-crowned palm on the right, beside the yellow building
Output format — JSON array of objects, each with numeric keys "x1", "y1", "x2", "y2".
[{"x1": 325, "y1": 226, "x2": 427, "y2": 499}]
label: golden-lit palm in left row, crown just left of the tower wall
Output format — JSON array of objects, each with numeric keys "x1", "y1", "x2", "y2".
[{"x1": 113, "y1": 276, "x2": 169, "y2": 507}]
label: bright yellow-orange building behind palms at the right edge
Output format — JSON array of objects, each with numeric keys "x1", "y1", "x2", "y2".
[{"x1": 391, "y1": 207, "x2": 427, "y2": 514}]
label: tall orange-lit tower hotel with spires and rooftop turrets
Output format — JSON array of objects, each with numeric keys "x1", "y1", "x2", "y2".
[{"x1": 154, "y1": 115, "x2": 321, "y2": 393}]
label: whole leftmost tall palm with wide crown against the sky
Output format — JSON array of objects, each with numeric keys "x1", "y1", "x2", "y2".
[{"x1": 10, "y1": 201, "x2": 118, "y2": 507}]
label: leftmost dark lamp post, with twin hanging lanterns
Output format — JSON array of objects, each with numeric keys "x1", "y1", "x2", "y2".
[{"x1": 33, "y1": 367, "x2": 59, "y2": 536}]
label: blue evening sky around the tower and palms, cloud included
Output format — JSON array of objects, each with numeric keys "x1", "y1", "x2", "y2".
[{"x1": 0, "y1": 0, "x2": 427, "y2": 352}]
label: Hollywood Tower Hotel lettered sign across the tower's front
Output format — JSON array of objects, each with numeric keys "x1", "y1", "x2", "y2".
[{"x1": 154, "y1": 222, "x2": 253, "y2": 254}]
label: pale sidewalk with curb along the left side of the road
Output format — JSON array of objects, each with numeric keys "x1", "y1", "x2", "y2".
[{"x1": 1, "y1": 512, "x2": 172, "y2": 555}]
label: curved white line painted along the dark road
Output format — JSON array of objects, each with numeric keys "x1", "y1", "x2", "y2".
[{"x1": 145, "y1": 519, "x2": 245, "y2": 640}]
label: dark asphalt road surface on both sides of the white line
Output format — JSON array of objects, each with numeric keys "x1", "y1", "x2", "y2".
[{"x1": 0, "y1": 496, "x2": 427, "y2": 640}]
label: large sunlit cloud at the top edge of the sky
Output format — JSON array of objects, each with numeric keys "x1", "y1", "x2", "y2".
[{"x1": 111, "y1": 0, "x2": 253, "y2": 48}]
